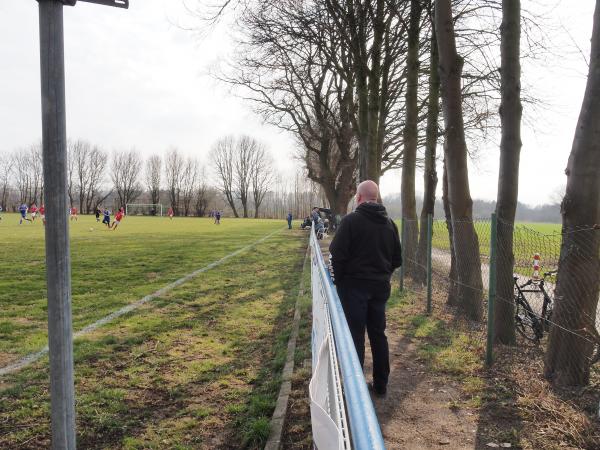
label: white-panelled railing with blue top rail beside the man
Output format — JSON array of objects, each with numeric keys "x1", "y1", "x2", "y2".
[{"x1": 309, "y1": 227, "x2": 385, "y2": 450}]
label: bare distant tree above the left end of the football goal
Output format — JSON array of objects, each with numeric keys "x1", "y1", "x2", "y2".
[{"x1": 110, "y1": 149, "x2": 142, "y2": 206}]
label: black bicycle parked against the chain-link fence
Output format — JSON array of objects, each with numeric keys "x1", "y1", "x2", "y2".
[{"x1": 513, "y1": 270, "x2": 557, "y2": 342}]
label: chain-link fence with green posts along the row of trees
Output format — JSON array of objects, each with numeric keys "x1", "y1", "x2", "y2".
[{"x1": 400, "y1": 215, "x2": 600, "y2": 385}]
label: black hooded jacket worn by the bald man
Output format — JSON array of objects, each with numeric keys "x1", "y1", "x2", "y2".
[{"x1": 329, "y1": 203, "x2": 402, "y2": 284}]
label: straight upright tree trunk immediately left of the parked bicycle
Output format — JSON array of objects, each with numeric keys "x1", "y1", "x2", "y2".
[{"x1": 494, "y1": 0, "x2": 523, "y2": 345}]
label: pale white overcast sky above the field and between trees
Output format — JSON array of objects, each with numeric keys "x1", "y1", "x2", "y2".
[{"x1": 0, "y1": 0, "x2": 595, "y2": 205}]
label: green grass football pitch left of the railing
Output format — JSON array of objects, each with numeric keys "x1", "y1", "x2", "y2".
[{"x1": 0, "y1": 214, "x2": 306, "y2": 449}]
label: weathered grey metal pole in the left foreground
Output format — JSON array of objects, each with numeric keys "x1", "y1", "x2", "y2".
[{"x1": 39, "y1": 0, "x2": 75, "y2": 450}]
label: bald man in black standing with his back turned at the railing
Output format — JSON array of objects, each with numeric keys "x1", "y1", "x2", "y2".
[{"x1": 329, "y1": 180, "x2": 402, "y2": 396}]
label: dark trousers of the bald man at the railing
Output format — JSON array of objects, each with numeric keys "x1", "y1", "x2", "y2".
[{"x1": 337, "y1": 280, "x2": 390, "y2": 388}]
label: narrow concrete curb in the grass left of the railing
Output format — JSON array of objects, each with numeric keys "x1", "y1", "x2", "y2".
[{"x1": 264, "y1": 246, "x2": 310, "y2": 450}]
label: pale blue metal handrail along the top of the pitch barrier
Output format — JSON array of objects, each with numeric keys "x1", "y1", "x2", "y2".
[{"x1": 310, "y1": 225, "x2": 385, "y2": 450}]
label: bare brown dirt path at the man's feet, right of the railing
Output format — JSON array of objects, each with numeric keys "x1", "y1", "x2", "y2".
[{"x1": 365, "y1": 332, "x2": 477, "y2": 450}]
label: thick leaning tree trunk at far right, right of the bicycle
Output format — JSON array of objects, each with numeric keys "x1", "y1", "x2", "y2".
[{"x1": 545, "y1": 0, "x2": 600, "y2": 387}]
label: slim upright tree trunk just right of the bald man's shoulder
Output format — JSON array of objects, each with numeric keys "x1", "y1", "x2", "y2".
[{"x1": 401, "y1": 0, "x2": 426, "y2": 278}]
